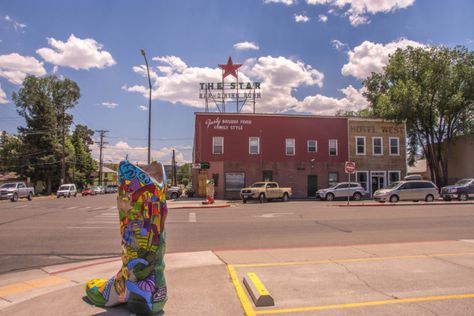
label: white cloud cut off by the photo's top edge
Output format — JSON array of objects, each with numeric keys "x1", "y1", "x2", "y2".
[{"x1": 306, "y1": 0, "x2": 415, "y2": 26}]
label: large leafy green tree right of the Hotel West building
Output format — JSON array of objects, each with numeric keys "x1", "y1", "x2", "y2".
[{"x1": 364, "y1": 47, "x2": 474, "y2": 186}]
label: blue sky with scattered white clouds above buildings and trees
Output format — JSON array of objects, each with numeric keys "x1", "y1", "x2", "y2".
[{"x1": 0, "y1": 0, "x2": 474, "y2": 163}]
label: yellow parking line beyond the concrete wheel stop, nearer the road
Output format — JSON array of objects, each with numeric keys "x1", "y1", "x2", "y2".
[{"x1": 233, "y1": 252, "x2": 474, "y2": 268}]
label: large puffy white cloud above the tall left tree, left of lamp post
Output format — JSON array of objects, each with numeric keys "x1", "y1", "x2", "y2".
[{"x1": 36, "y1": 34, "x2": 115, "y2": 70}]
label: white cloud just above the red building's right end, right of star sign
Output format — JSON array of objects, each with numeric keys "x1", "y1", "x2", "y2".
[{"x1": 294, "y1": 85, "x2": 369, "y2": 115}]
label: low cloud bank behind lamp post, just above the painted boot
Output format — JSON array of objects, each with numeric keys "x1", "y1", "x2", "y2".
[{"x1": 91, "y1": 140, "x2": 192, "y2": 164}]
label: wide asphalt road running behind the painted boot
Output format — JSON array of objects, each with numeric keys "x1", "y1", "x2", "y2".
[{"x1": 0, "y1": 195, "x2": 474, "y2": 273}]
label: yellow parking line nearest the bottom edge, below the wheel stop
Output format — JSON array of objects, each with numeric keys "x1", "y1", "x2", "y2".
[{"x1": 255, "y1": 294, "x2": 474, "y2": 315}]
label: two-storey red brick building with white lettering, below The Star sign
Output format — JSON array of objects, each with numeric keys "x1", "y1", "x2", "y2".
[{"x1": 193, "y1": 112, "x2": 349, "y2": 198}]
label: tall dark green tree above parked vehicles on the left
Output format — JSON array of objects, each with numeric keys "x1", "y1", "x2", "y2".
[{"x1": 12, "y1": 76, "x2": 80, "y2": 194}]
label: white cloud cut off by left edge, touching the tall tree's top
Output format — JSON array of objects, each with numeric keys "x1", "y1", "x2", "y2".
[{"x1": 0, "y1": 53, "x2": 46, "y2": 85}]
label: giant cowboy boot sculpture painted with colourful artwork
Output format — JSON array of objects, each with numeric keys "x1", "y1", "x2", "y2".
[{"x1": 86, "y1": 161, "x2": 168, "y2": 315}]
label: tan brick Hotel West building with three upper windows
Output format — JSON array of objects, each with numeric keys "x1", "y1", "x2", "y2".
[{"x1": 348, "y1": 118, "x2": 407, "y2": 195}]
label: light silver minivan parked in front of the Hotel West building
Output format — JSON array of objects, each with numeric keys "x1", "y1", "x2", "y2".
[{"x1": 374, "y1": 180, "x2": 439, "y2": 203}]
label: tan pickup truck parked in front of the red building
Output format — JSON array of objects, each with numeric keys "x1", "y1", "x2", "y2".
[{"x1": 240, "y1": 182, "x2": 291, "y2": 203}]
